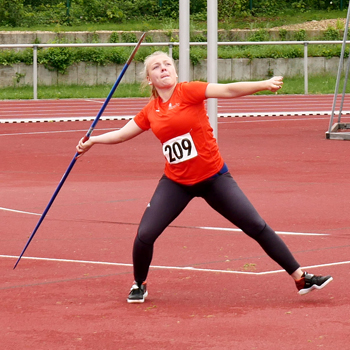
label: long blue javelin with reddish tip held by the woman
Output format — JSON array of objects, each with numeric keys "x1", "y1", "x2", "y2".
[{"x1": 13, "y1": 33, "x2": 146, "y2": 269}]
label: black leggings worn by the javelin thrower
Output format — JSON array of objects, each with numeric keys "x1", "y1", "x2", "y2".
[{"x1": 133, "y1": 172, "x2": 300, "y2": 283}]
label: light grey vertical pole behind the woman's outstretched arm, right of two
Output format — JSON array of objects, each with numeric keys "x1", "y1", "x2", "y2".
[{"x1": 207, "y1": 0, "x2": 218, "y2": 139}]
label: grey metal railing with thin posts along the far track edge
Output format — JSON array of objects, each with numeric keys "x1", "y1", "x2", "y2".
[{"x1": 0, "y1": 40, "x2": 350, "y2": 100}]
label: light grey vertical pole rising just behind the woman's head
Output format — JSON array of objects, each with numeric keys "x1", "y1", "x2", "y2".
[{"x1": 179, "y1": 0, "x2": 190, "y2": 82}]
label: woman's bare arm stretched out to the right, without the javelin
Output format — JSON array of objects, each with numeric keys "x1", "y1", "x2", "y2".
[{"x1": 205, "y1": 77, "x2": 283, "y2": 98}]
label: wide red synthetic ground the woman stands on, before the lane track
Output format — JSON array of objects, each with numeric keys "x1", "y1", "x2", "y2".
[{"x1": 0, "y1": 96, "x2": 350, "y2": 350}]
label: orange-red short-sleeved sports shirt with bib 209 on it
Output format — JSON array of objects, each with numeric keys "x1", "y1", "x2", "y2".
[{"x1": 134, "y1": 81, "x2": 224, "y2": 185}]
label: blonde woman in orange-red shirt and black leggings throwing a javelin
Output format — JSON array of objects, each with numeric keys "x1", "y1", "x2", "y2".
[{"x1": 77, "y1": 52, "x2": 333, "y2": 303}]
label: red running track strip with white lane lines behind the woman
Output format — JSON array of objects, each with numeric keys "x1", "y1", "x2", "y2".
[{"x1": 0, "y1": 95, "x2": 350, "y2": 123}]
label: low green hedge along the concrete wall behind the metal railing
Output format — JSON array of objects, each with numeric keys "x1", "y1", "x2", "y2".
[{"x1": 0, "y1": 29, "x2": 349, "y2": 74}]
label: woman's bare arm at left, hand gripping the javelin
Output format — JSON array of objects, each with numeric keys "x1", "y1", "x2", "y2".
[{"x1": 76, "y1": 120, "x2": 144, "y2": 155}]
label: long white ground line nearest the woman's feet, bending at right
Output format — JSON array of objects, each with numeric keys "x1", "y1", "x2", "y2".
[{"x1": 0, "y1": 255, "x2": 350, "y2": 276}]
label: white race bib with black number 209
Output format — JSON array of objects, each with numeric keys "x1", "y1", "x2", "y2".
[{"x1": 163, "y1": 133, "x2": 198, "y2": 164}]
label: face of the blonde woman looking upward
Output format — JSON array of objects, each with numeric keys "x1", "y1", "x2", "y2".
[{"x1": 147, "y1": 54, "x2": 177, "y2": 89}]
